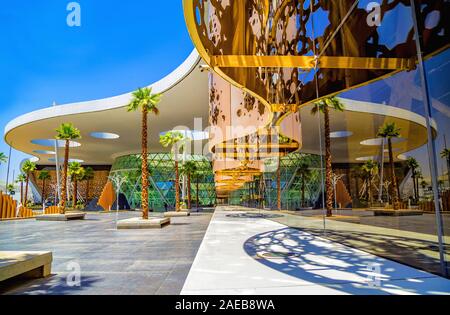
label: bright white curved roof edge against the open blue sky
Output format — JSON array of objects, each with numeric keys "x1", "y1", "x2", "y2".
[{"x1": 4, "y1": 48, "x2": 201, "y2": 142}]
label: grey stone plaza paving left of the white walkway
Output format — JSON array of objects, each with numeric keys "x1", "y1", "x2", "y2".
[{"x1": 0, "y1": 212, "x2": 211, "y2": 294}]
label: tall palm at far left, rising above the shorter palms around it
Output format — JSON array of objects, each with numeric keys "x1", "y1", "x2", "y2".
[{"x1": 56, "y1": 123, "x2": 81, "y2": 214}]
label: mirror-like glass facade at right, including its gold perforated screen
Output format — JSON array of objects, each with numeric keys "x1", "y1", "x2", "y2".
[{"x1": 186, "y1": 0, "x2": 450, "y2": 276}]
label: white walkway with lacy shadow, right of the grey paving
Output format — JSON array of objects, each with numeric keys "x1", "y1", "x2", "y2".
[{"x1": 181, "y1": 207, "x2": 450, "y2": 295}]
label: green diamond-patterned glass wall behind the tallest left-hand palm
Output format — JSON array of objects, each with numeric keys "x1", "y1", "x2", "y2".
[{"x1": 110, "y1": 153, "x2": 216, "y2": 211}]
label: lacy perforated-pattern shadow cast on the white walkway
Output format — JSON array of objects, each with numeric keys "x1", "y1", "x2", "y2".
[{"x1": 244, "y1": 228, "x2": 450, "y2": 294}]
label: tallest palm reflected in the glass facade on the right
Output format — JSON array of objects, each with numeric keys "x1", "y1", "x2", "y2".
[{"x1": 311, "y1": 97, "x2": 345, "y2": 217}]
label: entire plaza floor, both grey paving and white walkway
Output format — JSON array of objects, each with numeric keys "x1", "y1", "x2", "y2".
[{"x1": 0, "y1": 207, "x2": 450, "y2": 295}]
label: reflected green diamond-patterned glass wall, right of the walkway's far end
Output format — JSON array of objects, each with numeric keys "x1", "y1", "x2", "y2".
[{"x1": 229, "y1": 153, "x2": 322, "y2": 209}]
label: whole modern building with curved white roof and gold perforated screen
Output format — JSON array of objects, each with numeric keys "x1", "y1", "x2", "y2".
[{"x1": 4, "y1": 0, "x2": 450, "y2": 275}]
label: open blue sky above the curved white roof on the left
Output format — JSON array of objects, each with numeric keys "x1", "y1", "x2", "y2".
[{"x1": 0, "y1": 0, "x2": 193, "y2": 185}]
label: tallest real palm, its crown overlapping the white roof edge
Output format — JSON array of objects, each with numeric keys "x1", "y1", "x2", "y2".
[{"x1": 127, "y1": 88, "x2": 161, "y2": 220}]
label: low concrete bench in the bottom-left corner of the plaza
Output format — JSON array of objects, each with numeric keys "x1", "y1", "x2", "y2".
[{"x1": 0, "y1": 251, "x2": 53, "y2": 281}]
